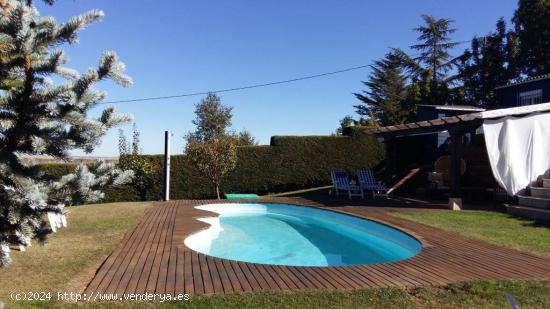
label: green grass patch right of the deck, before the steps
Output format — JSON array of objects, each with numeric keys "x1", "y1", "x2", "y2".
[{"x1": 392, "y1": 210, "x2": 550, "y2": 256}]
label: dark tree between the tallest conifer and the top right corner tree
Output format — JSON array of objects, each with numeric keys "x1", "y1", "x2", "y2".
[{"x1": 458, "y1": 18, "x2": 519, "y2": 108}]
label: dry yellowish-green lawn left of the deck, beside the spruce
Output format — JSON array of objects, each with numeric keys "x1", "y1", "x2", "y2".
[{"x1": 0, "y1": 203, "x2": 150, "y2": 307}]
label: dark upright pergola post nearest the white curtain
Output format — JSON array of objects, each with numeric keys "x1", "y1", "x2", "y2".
[{"x1": 449, "y1": 130, "x2": 463, "y2": 210}]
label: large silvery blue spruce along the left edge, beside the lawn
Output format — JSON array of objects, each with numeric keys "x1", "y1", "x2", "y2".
[{"x1": 0, "y1": 0, "x2": 131, "y2": 265}]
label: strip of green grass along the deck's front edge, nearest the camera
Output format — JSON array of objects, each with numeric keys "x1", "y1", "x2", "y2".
[{"x1": 33, "y1": 281, "x2": 550, "y2": 309}]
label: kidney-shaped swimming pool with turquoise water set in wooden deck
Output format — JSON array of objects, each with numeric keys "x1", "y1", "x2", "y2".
[{"x1": 184, "y1": 203, "x2": 422, "y2": 266}]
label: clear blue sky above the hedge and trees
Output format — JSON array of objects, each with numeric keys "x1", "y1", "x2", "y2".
[{"x1": 39, "y1": 0, "x2": 517, "y2": 156}]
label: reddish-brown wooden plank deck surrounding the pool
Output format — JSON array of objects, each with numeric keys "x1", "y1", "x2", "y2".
[{"x1": 85, "y1": 198, "x2": 550, "y2": 295}]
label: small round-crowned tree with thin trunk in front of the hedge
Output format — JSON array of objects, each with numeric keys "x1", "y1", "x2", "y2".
[{"x1": 185, "y1": 135, "x2": 237, "y2": 199}]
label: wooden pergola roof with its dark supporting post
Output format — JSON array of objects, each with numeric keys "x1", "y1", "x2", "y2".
[{"x1": 365, "y1": 103, "x2": 550, "y2": 210}]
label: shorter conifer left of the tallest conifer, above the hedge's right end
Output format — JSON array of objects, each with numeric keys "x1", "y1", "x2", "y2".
[{"x1": 354, "y1": 51, "x2": 414, "y2": 126}]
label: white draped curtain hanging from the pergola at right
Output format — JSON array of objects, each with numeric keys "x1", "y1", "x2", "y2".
[{"x1": 483, "y1": 113, "x2": 550, "y2": 195}]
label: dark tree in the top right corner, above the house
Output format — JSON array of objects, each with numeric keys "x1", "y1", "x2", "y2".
[{"x1": 512, "y1": 0, "x2": 550, "y2": 76}]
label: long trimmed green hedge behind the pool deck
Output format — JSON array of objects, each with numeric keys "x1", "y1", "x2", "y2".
[{"x1": 38, "y1": 134, "x2": 384, "y2": 201}]
